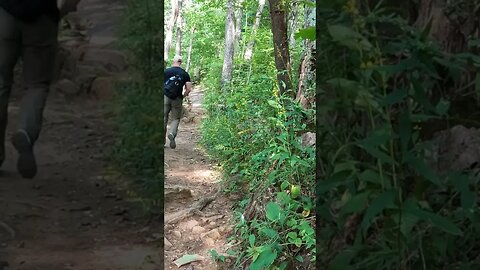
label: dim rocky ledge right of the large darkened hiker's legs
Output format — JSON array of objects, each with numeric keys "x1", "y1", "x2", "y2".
[{"x1": 52, "y1": 10, "x2": 128, "y2": 100}]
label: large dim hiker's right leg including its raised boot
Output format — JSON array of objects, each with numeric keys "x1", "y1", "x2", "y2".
[{"x1": 12, "y1": 16, "x2": 58, "y2": 178}]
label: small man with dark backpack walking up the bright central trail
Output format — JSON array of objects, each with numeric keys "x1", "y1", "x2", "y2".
[{"x1": 163, "y1": 55, "x2": 192, "y2": 149}]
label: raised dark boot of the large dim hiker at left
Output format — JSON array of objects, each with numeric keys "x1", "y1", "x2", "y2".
[{"x1": 12, "y1": 130, "x2": 37, "y2": 178}]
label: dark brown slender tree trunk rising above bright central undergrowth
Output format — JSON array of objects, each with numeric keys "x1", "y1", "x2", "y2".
[{"x1": 269, "y1": 0, "x2": 295, "y2": 98}]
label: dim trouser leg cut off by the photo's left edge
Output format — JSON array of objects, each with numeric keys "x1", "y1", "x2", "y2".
[{"x1": 0, "y1": 8, "x2": 20, "y2": 164}]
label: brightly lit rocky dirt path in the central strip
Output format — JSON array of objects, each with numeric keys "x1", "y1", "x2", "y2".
[{"x1": 165, "y1": 87, "x2": 233, "y2": 270}]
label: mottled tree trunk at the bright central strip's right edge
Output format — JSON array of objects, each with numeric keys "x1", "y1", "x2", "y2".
[{"x1": 296, "y1": 0, "x2": 316, "y2": 108}]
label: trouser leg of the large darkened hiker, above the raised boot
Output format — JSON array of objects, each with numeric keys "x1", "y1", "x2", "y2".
[{"x1": 19, "y1": 16, "x2": 58, "y2": 144}]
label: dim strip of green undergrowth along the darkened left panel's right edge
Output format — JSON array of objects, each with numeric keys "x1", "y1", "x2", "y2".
[{"x1": 109, "y1": 0, "x2": 164, "y2": 211}]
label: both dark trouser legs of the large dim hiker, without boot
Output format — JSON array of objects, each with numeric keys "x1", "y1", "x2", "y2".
[{"x1": 0, "y1": 8, "x2": 58, "y2": 157}]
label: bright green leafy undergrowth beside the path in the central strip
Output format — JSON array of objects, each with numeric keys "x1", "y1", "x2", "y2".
[{"x1": 202, "y1": 33, "x2": 315, "y2": 270}]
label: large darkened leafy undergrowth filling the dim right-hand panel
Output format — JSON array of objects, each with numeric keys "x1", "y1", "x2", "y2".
[{"x1": 317, "y1": 0, "x2": 480, "y2": 270}]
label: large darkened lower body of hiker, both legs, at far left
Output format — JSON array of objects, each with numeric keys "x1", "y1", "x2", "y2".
[{"x1": 0, "y1": 0, "x2": 80, "y2": 178}]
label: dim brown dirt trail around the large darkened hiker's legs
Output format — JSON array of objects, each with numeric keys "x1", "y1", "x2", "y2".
[{"x1": 0, "y1": 0, "x2": 163, "y2": 270}]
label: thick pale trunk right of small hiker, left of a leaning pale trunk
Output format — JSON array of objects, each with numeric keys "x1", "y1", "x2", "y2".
[{"x1": 222, "y1": 0, "x2": 235, "y2": 87}]
